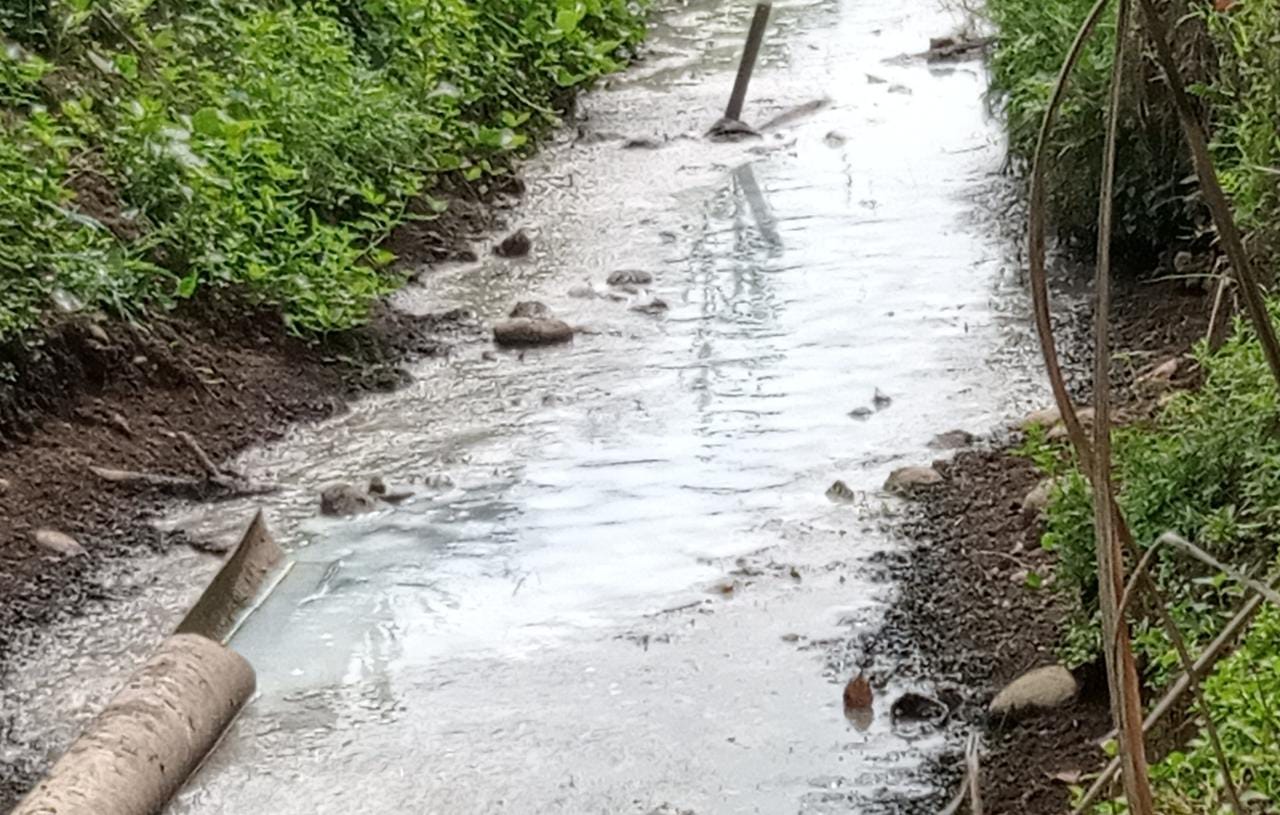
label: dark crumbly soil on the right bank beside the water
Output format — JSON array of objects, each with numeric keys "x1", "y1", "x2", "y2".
[{"x1": 869, "y1": 276, "x2": 1208, "y2": 815}]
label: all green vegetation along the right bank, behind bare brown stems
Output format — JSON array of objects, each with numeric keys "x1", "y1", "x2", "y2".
[{"x1": 987, "y1": 0, "x2": 1280, "y2": 814}]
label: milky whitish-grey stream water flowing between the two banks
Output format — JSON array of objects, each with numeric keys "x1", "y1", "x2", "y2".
[{"x1": 5, "y1": 0, "x2": 1042, "y2": 815}]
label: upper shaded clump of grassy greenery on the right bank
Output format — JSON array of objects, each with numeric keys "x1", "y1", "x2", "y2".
[{"x1": 987, "y1": 0, "x2": 1280, "y2": 252}]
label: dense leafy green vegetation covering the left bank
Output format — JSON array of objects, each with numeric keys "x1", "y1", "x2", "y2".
[{"x1": 0, "y1": 0, "x2": 644, "y2": 342}]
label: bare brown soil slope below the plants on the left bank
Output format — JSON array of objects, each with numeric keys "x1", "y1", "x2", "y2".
[{"x1": 0, "y1": 191, "x2": 498, "y2": 811}]
